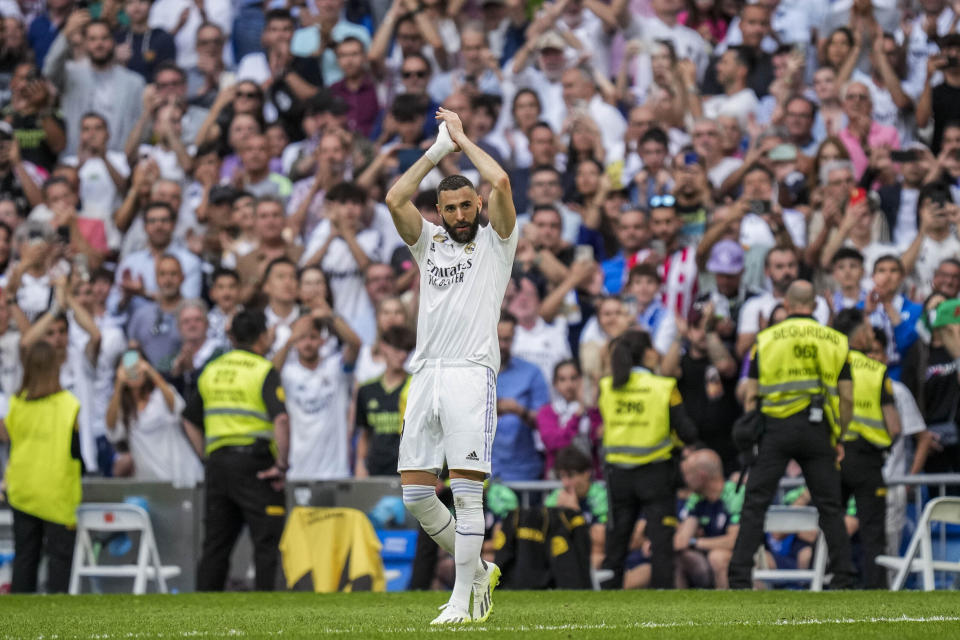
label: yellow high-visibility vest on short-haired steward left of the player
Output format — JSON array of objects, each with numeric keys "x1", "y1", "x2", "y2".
[{"x1": 197, "y1": 349, "x2": 282, "y2": 455}]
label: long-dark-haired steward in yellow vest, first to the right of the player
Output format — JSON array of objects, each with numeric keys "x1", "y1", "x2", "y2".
[{"x1": 598, "y1": 330, "x2": 697, "y2": 589}]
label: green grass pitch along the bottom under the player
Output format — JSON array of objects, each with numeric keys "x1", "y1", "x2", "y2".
[{"x1": 0, "y1": 591, "x2": 960, "y2": 640}]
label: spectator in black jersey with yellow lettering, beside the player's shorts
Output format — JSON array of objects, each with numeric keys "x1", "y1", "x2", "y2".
[{"x1": 354, "y1": 325, "x2": 417, "y2": 478}]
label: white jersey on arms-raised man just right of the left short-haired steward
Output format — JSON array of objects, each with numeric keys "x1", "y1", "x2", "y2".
[{"x1": 280, "y1": 353, "x2": 353, "y2": 480}]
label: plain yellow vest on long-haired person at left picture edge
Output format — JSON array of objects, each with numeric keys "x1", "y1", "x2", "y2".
[{"x1": 5, "y1": 391, "x2": 81, "y2": 526}]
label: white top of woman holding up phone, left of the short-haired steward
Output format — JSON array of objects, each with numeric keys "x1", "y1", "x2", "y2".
[{"x1": 111, "y1": 389, "x2": 203, "y2": 487}]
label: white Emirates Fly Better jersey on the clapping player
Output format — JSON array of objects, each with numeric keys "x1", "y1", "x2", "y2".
[{"x1": 410, "y1": 220, "x2": 519, "y2": 373}]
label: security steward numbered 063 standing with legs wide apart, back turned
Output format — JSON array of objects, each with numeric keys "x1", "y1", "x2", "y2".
[{"x1": 728, "y1": 280, "x2": 853, "y2": 589}]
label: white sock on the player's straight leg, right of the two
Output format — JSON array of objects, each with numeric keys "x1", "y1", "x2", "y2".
[{"x1": 450, "y1": 478, "x2": 484, "y2": 611}]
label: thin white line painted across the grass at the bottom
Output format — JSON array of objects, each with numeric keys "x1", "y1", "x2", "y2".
[{"x1": 2, "y1": 615, "x2": 960, "y2": 640}]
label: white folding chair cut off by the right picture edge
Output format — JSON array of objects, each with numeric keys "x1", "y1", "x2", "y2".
[{"x1": 877, "y1": 496, "x2": 960, "y2": 591}]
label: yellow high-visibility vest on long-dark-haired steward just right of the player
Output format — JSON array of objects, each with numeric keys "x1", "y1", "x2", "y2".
[{"x1": 597, "y1": 370, "x2": 682, "y2": 466}]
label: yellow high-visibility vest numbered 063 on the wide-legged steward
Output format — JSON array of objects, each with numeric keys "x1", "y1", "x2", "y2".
[{"x1": 754, "y1": 317, "x2": 848, "y2": 435}]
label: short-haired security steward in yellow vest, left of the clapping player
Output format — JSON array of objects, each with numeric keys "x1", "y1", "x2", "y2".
[{"x1": 183, "y1": 310, "x2": 290, "y2": 591}]
